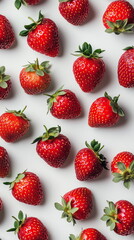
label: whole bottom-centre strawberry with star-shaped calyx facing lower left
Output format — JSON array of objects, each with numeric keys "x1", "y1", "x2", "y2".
[{"x1": 55, "y1": 187, "x2": 93, "y2": 224}]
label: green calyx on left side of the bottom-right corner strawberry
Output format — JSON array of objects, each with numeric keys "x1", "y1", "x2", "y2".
[{"x1": 101, "y1": 201, "x2": 118, "y2": 231}]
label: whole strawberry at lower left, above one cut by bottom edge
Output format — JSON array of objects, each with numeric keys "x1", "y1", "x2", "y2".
[{"x1": 4, "y1": 171, "x2": 43, "y2": 205}]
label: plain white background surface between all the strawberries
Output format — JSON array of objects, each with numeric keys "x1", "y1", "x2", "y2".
[{"x1": 0, "y1": 0, "x2": 134, "y2": 240}]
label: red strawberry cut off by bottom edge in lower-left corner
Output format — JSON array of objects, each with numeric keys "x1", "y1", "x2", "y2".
[{"x1": 7, "y1": 211, "x2": 48, "y2": 240}]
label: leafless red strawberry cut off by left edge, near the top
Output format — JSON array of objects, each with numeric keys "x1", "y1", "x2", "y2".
[{"x1": 0, "y1": 15, "x2": 15, "y2": 49}]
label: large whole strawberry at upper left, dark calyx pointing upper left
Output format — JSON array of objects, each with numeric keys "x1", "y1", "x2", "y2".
[{"x1": 20, "y1": 11, "x2": 59, "y2": 57}]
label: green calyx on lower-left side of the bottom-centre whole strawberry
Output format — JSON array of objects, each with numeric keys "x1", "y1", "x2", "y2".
[{"x1": 54, "y1": 198, "x2": 78, "y2": 225}]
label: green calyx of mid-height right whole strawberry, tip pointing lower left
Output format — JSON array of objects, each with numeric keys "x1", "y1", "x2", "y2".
[{"x1": 104, "y1": 92, "x2": 125, "y2": 117}]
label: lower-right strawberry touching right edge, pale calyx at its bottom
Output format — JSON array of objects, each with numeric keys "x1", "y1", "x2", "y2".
[{"x1": 111, "y1": 152, "x2": 134, "y2": 189}]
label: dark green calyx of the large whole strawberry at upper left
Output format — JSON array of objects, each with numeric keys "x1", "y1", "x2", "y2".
[{"x1": 19, "y1": 11, "x2": 44, "y2": 36}]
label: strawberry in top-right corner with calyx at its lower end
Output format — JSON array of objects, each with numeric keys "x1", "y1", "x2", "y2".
[{"x1": 103, "y1": 0, "x2": 134, "y2": 34}]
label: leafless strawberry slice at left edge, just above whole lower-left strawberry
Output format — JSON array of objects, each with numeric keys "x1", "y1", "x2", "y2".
[{"x1": 0, "y1": 146, "x2": 10, "y2": 178}]
